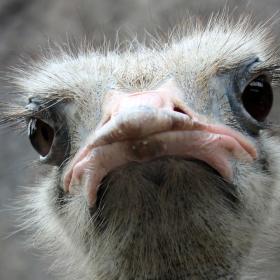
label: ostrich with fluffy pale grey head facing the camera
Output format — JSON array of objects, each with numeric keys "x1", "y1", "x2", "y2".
[{"x1": 1, "y1": 16, "x2": 280, "y2": 280}]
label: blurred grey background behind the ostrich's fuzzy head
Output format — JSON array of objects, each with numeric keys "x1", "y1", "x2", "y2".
[{"x1": 0, "y1": 0, "x2": 280, "y2": 280}]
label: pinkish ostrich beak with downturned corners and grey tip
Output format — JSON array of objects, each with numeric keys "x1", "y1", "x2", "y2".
[{"x1": 64, "y1": 81, "x2": 257, "y2": 206}]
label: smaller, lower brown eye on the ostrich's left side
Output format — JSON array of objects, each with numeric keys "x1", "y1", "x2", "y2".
[{"x1": 28, "y1": 119, "x2": 54, "y2": 157}]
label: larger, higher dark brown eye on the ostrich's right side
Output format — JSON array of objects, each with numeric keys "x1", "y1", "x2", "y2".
[{"x1": 241, "y1": 76, "x2": 273, "y2": 122}]
